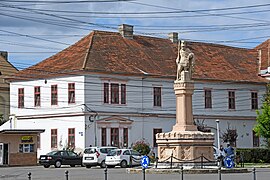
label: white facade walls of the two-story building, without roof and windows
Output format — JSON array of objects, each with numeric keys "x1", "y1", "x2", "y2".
[{"x1": 1, "y1": 74, "x2": 265, "y2": 155}]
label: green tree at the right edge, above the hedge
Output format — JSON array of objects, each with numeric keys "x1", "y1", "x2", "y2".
[{"x1": 253, "y1": 84, "x2": 270, "y2": 148}]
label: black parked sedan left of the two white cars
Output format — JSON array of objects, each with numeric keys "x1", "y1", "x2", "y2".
[{"x1": 39, "y1": 150, "x2": 82, "y2": 168}]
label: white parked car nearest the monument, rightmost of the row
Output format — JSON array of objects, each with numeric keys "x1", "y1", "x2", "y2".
[{"x1": 105, "y1": 149, "x2": 142, "y2": 168}]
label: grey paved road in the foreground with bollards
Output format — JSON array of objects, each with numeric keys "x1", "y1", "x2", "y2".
[{"x1": 0, "y1": 166, "x2": 270, "y2": 180}]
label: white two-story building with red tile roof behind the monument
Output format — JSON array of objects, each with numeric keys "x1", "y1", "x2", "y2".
[{"x1": 1, "y1": 25, "x2": 265, "y2": 157}]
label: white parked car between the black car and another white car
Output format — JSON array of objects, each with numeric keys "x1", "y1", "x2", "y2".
[{"x1": 83, "y1": 146, "x2": 117, "y2": 168}]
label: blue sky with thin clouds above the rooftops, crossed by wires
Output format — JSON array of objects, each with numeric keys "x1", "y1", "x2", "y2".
[{"x1": 0, "y1": 0, "x2": 270, "y2": 69}]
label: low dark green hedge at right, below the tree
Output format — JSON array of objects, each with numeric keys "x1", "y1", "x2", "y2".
[{"x1": 236, "y1": 148, "x2": 270, "y2": 163}]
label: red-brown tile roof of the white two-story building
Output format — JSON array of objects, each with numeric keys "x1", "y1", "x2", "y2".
[{"x1": 14, "y1": 31, "x2": 265, "y2": 82}]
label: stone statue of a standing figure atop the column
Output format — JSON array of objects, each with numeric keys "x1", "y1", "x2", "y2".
[{"x1": 176, "y1": 41, "x2": 195, "y2": 81}]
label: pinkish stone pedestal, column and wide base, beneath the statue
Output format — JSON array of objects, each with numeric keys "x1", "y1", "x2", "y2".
[{"x1": 156, "y1": 75, "x2": 214, "y2": 161}]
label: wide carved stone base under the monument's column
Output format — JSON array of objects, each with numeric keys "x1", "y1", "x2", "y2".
[{"x1": 156, "y1": 131, "x2": 214, "y2": 161}]
